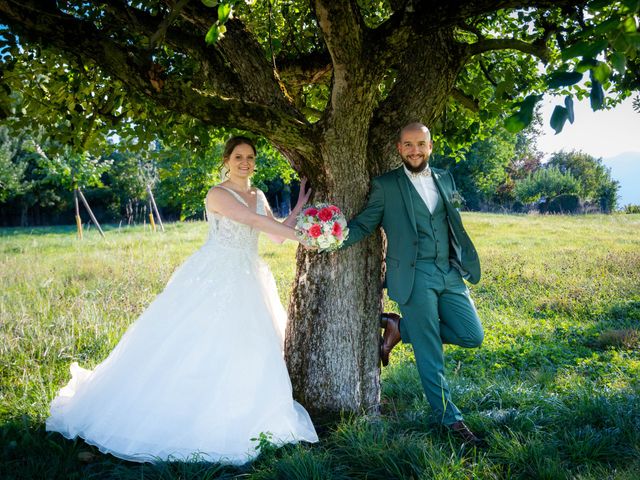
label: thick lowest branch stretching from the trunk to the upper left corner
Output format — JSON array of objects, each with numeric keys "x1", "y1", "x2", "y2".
[{"x1": 0, "y1": 0, "x2": 313, "y2": 152}]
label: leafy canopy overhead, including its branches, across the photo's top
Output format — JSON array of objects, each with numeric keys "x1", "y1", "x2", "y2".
[{"x1": 0, "y1": 0, "x2": 640, "y2": 163}]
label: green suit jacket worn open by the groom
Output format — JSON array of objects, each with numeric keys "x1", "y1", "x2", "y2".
[{"x1": 344, "y1": 167, "x2": 480, "y2": 304}]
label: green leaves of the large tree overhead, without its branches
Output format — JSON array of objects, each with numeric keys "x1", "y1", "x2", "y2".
[{"x1": 0, "y1": 0, "x2": 640, "y2": 163}]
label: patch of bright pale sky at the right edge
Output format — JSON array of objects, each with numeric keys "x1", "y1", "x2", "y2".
[{"x1": 538, "y1": 97, "x2": 640, "y2": 158}]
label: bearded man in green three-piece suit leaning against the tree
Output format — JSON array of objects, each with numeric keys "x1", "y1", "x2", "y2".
[{"x1": 344, "y1": 123, "x2": 484, "y2": 445}]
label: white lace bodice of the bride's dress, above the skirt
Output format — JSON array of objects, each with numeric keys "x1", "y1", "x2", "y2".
[{"x1": 205, "y1": 185, "x2": 267, "y2": 255}]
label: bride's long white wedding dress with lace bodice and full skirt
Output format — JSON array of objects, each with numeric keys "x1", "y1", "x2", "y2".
[{"x1": 46, "y1": 187, "x2": 318, "y2": 464}]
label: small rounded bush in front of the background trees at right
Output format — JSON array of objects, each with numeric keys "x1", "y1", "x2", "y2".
[{"x1": 515, "y1": 166, "x2": 580, "y2": 203}]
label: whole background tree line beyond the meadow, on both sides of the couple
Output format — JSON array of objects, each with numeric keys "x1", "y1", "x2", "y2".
[{"x1": 0, "y1": 117, "x2": 618, "y2": 226}]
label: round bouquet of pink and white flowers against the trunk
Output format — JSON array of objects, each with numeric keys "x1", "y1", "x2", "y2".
[{"x1": 296, "y1": 203, "x2": 349, "y2": 252}]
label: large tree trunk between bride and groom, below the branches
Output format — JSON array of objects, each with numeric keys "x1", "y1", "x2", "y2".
[{"x1": 285, "y1": 66, "x2": 390, "y2": 415}]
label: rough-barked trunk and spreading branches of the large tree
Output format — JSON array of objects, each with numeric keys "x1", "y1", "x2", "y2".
[{"x1": 0, "y1": 0, "x2": 580, "y2": 414}]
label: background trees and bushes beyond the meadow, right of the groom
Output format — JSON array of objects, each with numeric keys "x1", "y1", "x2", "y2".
[{"x1": 431, "y1": 116, "x2": 619, "y2": 213}]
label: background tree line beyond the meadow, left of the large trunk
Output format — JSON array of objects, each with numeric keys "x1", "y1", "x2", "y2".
[{"x1": 0, "y1": 125, "x2": 297, "y2": 226}]
